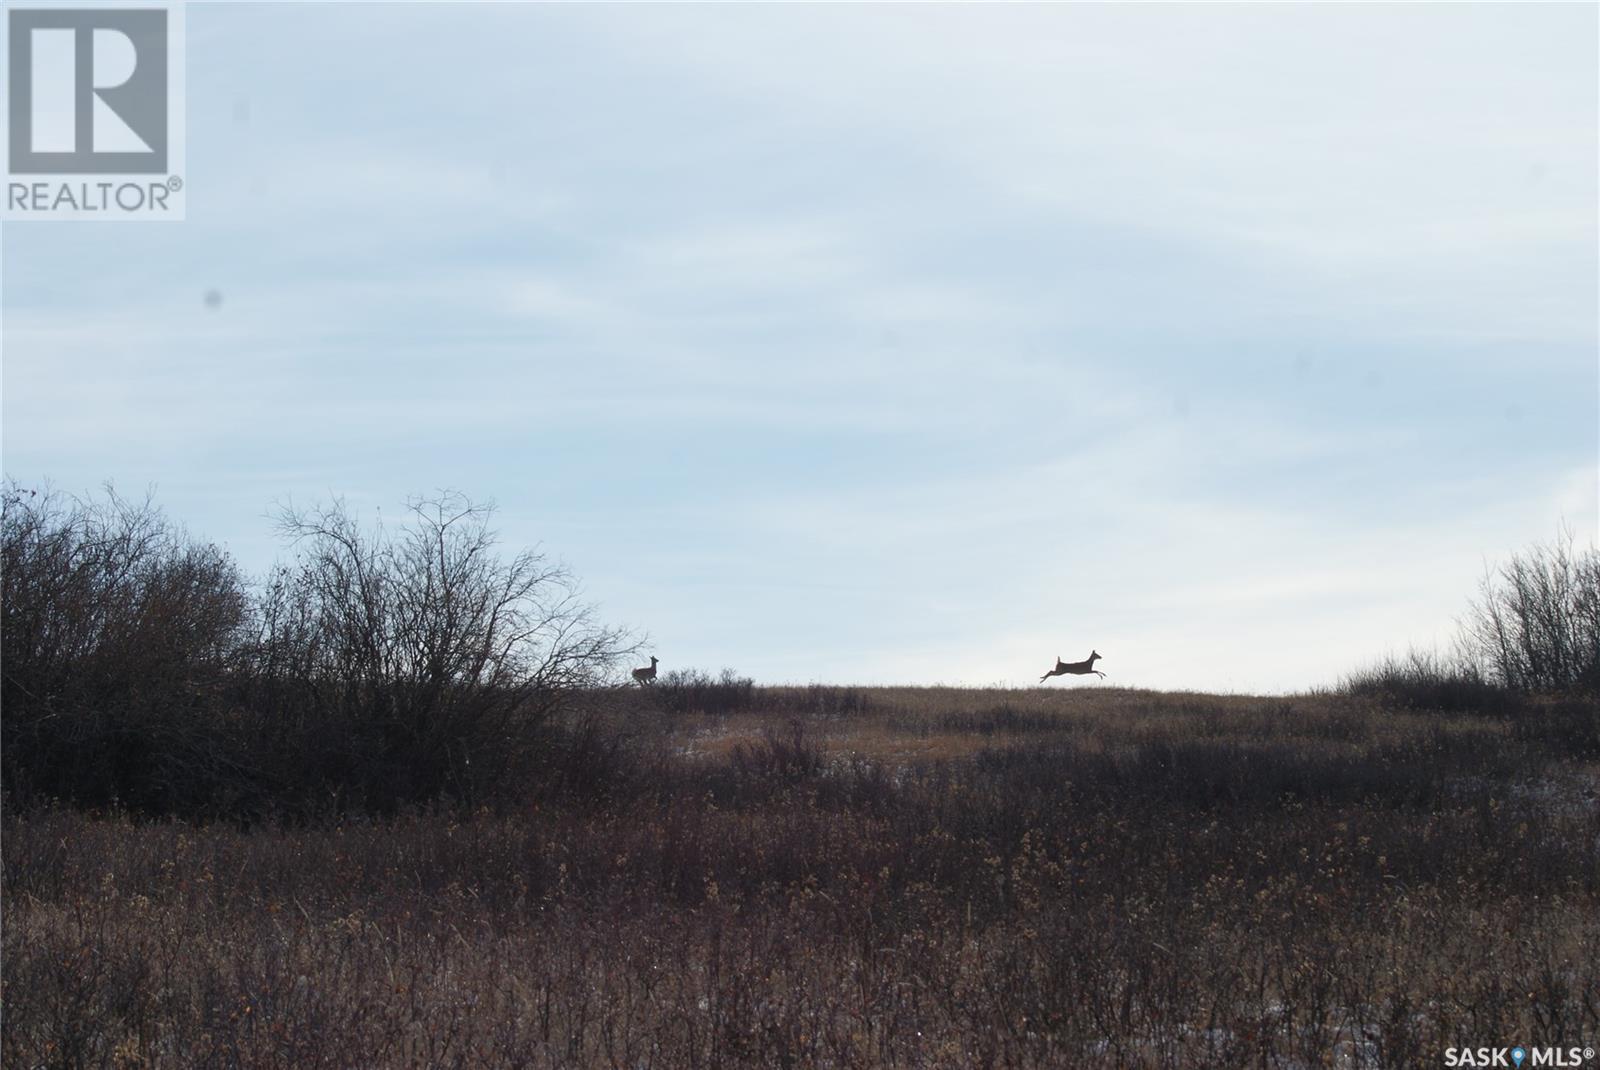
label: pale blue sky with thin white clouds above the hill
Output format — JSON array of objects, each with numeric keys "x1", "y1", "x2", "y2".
[{"x1": 0, "y1": 3, "x2": 1600, "y2": 691}]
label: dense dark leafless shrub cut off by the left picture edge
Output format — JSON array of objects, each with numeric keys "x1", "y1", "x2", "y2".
[{"x1": 0, "y1": 483, "x2": 248, "y2": 809}]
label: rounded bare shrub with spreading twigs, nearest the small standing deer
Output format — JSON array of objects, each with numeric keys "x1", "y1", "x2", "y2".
[{"x1": 248, "y1": 493, "x2": 632, "y2": 811}]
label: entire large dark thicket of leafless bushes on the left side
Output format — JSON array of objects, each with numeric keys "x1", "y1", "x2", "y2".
[{"x1": 0, "y1": 483, "x2": 629, "y2": 816}]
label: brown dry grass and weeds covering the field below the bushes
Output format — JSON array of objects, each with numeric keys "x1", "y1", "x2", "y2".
[{"x1": 0, "y1": 688, "x2": 1600, "y2": 1068}]
